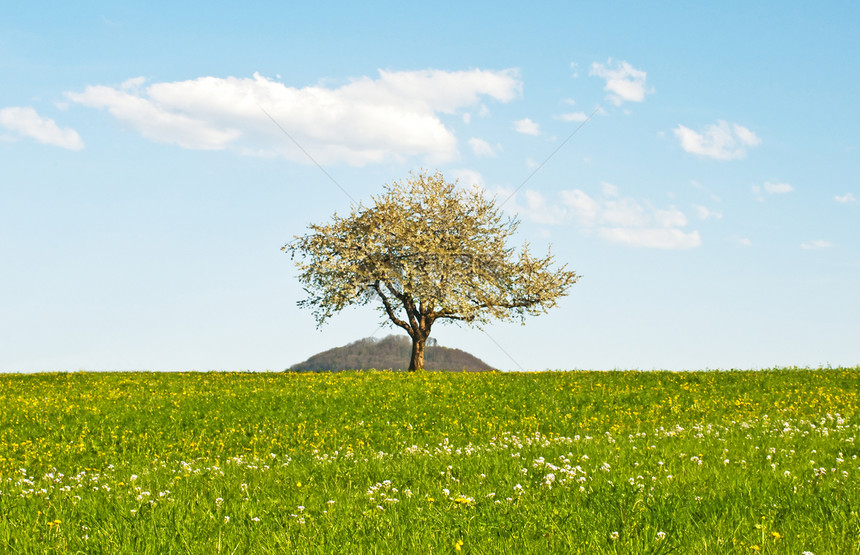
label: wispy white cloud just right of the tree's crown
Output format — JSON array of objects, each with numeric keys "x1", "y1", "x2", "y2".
[{"x1": 510, "y1": 183, "x2": 702, "y2": 249}]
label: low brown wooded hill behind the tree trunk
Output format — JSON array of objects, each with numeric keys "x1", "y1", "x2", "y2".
[{"x1": 287, "y1": 335, "x2": 493, "y2": 372}]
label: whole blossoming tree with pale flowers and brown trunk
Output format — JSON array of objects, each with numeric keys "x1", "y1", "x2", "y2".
[{"x1": 282, "y1": 172, "x2": 579, "y2": 370}]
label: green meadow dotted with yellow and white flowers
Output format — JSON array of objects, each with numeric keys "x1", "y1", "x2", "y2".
[{"x1": 0, "y1": 368, "x2": 860, "y2": 555}]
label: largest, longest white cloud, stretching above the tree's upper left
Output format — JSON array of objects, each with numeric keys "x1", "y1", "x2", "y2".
[{"x1": 67, "y1": 69, "x2": 522, "y2": 165}]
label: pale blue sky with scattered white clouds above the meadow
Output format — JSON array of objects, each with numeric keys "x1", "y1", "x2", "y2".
[{"x1": 0, "y1": 2, "x2": 860, "y2": 372}]
